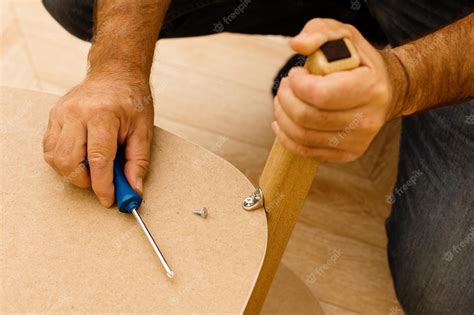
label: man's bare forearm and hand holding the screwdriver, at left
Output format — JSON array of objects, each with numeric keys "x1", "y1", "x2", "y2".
[{"x1": 43, "y1": 0, "x2": 169, "y2": 207}]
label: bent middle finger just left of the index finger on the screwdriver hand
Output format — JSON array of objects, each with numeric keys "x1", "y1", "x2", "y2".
[{"x1": 54, "y1": 121, "x2": 90, "y2": 188}]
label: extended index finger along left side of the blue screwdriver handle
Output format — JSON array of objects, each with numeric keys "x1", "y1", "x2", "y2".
[{"x1": 87, "y1": 114, "x2": 120, "y2": 207}]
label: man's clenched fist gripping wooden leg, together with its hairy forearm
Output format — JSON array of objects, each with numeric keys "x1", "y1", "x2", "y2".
[{"x1": 273, "y1": 13, "x2": 474, "y2": 162}]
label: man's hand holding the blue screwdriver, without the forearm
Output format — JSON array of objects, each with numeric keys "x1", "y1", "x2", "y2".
[{"x1": 43, "y1": 73, "x2": 154, "y2": 207}]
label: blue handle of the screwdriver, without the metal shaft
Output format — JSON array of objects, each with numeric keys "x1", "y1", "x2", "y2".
[{"x1": 114, "y1": 148, "x2": 142, "y2": 213}]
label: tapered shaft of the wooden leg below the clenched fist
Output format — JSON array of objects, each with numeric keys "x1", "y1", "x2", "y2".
[{"x1": 245, "y1": 140, "x2": 318, "y2": 314}]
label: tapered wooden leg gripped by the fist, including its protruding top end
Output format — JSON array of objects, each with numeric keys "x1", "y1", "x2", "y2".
[{"x1": 245, "y1": 38, "x2": 360, "y2": 314}]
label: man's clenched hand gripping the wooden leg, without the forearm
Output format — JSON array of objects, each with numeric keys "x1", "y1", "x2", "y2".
[{"x1": 272, "y1": 19, "x2": 399, "y2": 162}]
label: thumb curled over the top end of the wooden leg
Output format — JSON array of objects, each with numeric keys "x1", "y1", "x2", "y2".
[{"x1": 290, "y1": 18, "x2": 353, "y2": 56}]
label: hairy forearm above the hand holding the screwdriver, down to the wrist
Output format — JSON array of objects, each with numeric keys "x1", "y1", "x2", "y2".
[{"x1": 89, "y1": 0, "x2": 170, "y2": 80}]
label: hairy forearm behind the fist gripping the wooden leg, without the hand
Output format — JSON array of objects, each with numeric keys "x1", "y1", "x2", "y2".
[{"x1": 384, "y1": 14, "x2": 474, "y2": 116}]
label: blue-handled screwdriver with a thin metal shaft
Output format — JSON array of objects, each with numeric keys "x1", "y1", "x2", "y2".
[{"x1": 114, "y1": 150, "x2": 174, "y2": 278}]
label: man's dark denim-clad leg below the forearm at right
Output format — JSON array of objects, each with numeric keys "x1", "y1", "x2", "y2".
[{"x1": 386, "y1": 102, "x2": 474, "y2": 315}]
